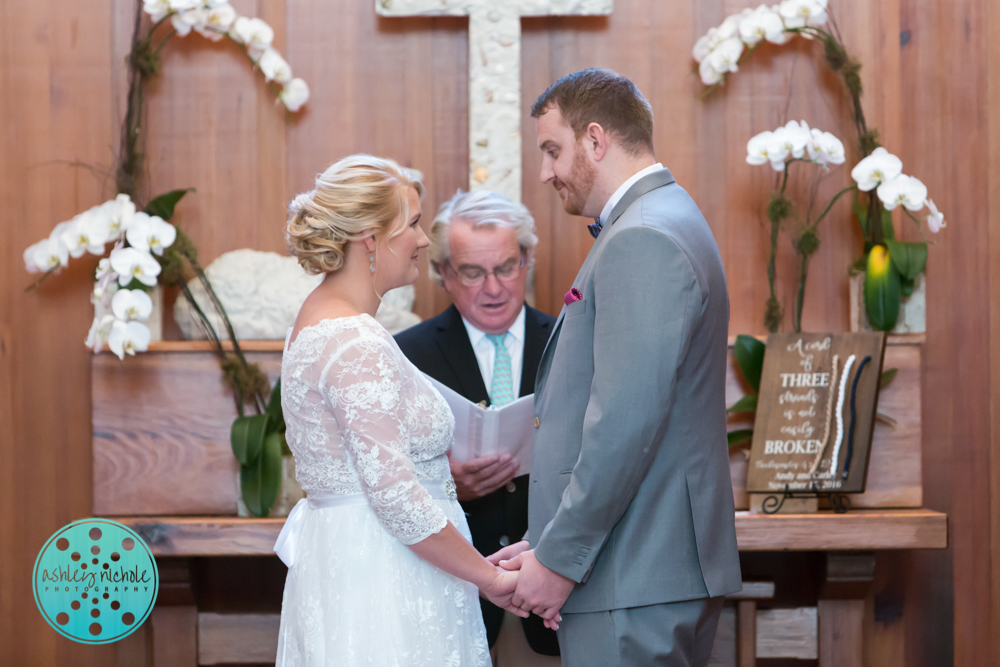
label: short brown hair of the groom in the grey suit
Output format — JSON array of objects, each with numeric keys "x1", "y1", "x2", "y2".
[{"x1": 531, "y1": 68, "x2": 653, "y2": 154}]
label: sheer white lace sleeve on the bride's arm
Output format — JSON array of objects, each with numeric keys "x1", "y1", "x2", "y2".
[{"x1": 319, "y1": 336, "x2": 448, "y2": 545}]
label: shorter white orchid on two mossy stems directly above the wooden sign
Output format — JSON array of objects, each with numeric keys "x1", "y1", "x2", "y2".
[{"x1": 747, "y1": 120, "x2": 851, "y2": 331}]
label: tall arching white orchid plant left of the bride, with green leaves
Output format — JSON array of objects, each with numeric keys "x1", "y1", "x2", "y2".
[{"x1": 23, "y1": 0, "x2": 300, "y2": 516}]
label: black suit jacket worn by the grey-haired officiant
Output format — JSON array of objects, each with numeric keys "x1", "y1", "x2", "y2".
[{"x1": 396, "y1": 306, "x2": 559, "y2": 655}]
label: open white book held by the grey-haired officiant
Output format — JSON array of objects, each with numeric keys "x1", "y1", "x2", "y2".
[{"x1": 427, "y1": 375, "x2": 535, "y2": 475}]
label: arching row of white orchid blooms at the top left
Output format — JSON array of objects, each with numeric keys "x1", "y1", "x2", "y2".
[{"x1": 143, "y1": 0, "x2": 309, "y2": 112}]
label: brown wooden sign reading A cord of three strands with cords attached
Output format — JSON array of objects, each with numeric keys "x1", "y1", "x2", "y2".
[{"x1": 747, "y1": 332, "x2": 886, "y2": 493}]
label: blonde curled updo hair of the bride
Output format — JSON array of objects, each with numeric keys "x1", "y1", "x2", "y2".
[{"x1": 285, "y1": 154, "x2": 423, "y2": 274}]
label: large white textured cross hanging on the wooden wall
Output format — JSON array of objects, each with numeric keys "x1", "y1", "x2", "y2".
[{"x1": 375, "y1": 0, "x2": 613, "y2": 202}]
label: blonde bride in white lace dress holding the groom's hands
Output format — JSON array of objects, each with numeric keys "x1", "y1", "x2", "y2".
[{"x1": 275, "y1": 155, "x2": 526, "y2": 667}]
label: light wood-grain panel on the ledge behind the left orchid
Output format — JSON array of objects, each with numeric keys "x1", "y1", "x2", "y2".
[{"x1": 92, "y1": 350, "x2": 281, "y2": 515}]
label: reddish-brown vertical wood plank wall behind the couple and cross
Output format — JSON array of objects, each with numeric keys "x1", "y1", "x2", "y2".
[{"x1": 0, "y1": 0, "x2": 1000, "y2": 666}]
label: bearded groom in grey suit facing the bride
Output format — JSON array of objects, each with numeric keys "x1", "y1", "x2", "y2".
[{"x1": 491, "y1": 69, "x2": 741, "y2": 667}]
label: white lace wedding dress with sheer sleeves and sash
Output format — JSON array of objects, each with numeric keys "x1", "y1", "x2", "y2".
[{"x1": 275, "y1": 315, "x2": 490, "y2": 667}]
